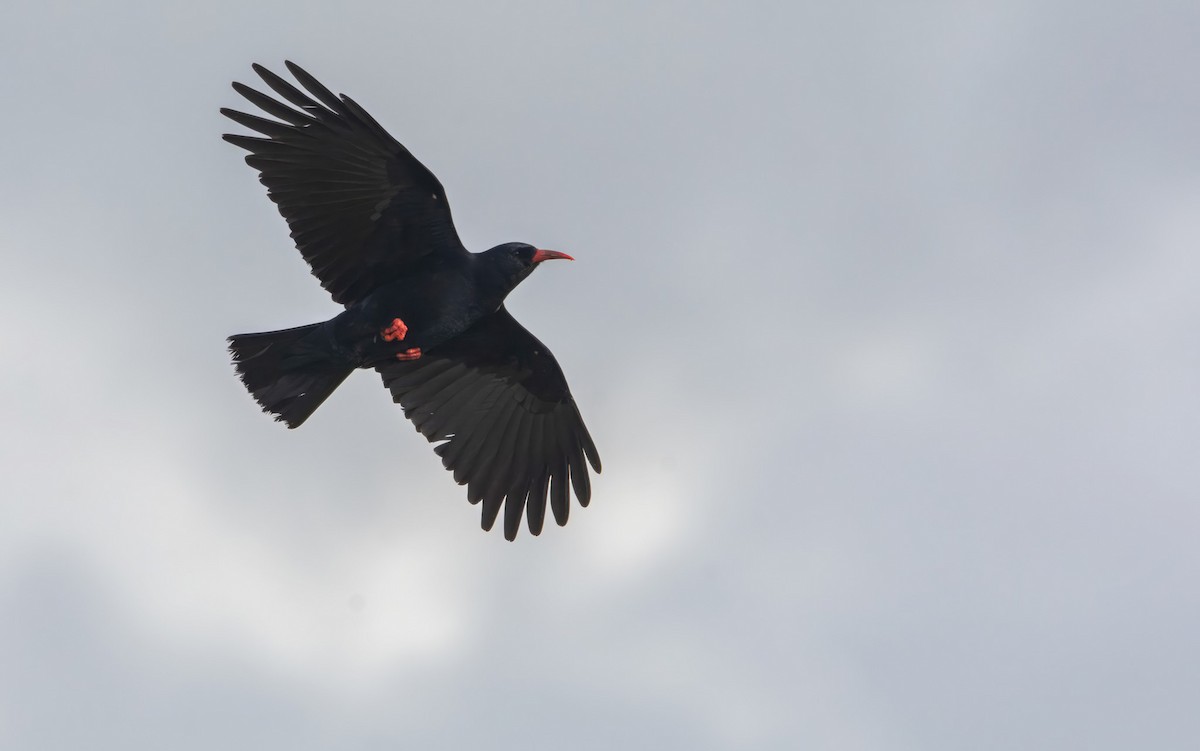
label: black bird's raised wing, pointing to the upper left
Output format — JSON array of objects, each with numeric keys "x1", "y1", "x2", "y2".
[{"x1": 221, "y1": 62, "x2": 467, "y2": 305}]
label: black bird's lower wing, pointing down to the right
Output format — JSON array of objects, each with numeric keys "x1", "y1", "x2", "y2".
[{"x1": 376, "y1": 307, "x2": 600, "y2": 540}]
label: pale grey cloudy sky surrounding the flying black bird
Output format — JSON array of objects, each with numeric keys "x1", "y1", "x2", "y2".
[{"x1": 0, "y1": 1, "x2": 1200, "y2": 751}]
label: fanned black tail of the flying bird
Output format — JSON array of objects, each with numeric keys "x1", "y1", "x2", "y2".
[{"x1": 229, "y1": 324, "x2": 355, "y2": 428}]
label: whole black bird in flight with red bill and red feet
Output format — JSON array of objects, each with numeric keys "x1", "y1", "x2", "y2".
[{"x1": 221, "y1": 62, "x2": 600, "y2": 540}]
